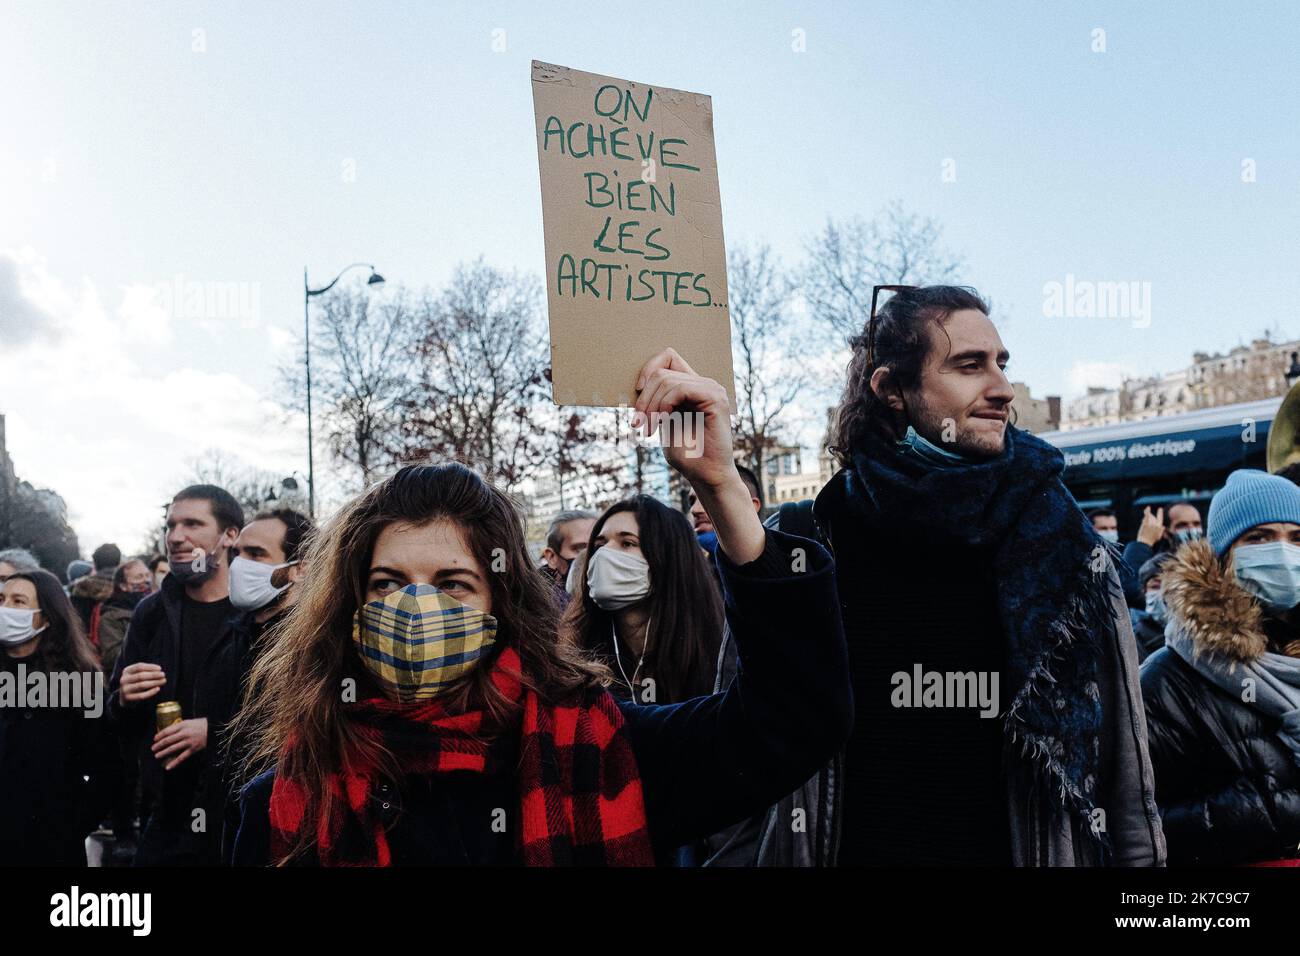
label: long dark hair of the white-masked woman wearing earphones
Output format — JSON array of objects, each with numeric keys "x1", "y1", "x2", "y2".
[{"x1": 562, "y1": 494, "x2": 724, "y2": 704}]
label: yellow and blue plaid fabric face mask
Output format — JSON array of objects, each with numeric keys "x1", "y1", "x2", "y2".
[{"x1": 352, "y1": 584, "x2": 497, "y2": 704}]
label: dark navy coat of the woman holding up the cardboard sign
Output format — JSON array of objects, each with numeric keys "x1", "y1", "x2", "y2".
[{"x1": 234, "y1": 531, "x2": 853, "y2": 865}]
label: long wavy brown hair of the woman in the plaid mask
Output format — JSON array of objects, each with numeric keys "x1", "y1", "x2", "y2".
[{"x1": 229, "y1": 463, "x2": 607, "y2": 862}]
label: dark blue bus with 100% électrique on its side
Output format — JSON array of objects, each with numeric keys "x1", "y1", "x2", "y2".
[{"x1": 1037, "y1": 395, "x2": 1282, "y2": 541}]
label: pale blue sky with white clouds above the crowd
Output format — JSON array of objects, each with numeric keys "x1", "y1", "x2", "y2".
[{"x1": 0, "y1": 0, "x2": 1300, "y2": 551}]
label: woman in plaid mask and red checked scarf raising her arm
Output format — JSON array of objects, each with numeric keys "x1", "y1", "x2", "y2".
[{"x1": 233, "y1": 351, "x2": 852, "y2": 866}]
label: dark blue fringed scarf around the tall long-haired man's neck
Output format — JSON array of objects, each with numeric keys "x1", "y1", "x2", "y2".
[{"x1": 849, "y1": 427, "x2": 1115, "y2": 847}]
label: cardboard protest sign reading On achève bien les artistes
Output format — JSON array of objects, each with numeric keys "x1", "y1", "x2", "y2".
[{"x1": 533, "y1": 60, "x2": 735, "y2": 406}]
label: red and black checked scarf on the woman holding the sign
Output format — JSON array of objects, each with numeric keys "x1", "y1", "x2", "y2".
[{"x1": 270, "y1": 648, "x2": 654, "y2": 866}]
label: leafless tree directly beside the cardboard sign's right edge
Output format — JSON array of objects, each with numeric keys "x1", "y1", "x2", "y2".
[{"x1": 727, "y1": 246, "x2": 807, "y2": 475}]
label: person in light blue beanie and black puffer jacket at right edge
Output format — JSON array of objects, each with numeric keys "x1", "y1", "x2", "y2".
[{"x1": 1141, "y1": 471, "x2": 1300, "y2": 866}]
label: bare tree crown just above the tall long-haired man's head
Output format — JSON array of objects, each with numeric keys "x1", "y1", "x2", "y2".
[{"x1": 802, "y1": 200, "x2": 965, "y2": 342}]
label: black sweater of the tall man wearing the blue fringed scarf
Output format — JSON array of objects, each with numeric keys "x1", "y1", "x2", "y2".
[{"x1": 816, "y1": 475, "x2": 1014, "y2": 866}]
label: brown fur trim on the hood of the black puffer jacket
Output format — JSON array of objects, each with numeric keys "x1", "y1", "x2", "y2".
[{"x1": 1160, "y1": 538, "x2": 1269, "y2": 663}]
